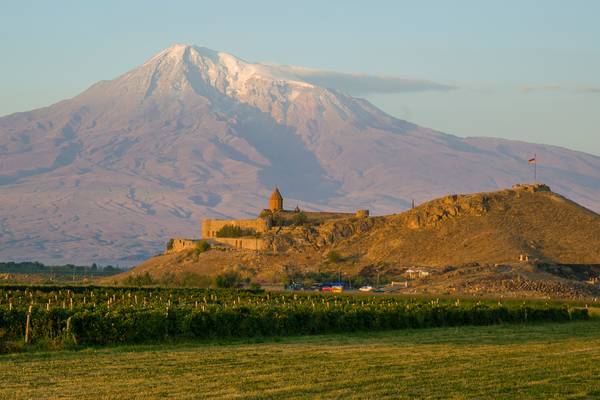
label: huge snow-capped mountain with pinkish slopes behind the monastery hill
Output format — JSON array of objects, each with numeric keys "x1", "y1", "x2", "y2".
[{"x1": 0, "y1": 45, "x2": 600, "y2": 263}]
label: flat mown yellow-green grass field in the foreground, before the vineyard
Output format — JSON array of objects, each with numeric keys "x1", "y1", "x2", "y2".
[{"x1": 0, "y1": 319, "x2": 600, "y2": 399}]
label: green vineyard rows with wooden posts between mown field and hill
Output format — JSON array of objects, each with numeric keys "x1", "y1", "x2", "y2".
[{"x1": 0, "y1": 286, "x2": 588, "y2": 348}]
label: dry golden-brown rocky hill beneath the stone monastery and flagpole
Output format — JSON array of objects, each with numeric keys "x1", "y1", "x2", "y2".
[{"x1": 110, "y1": 185, "x2": 600, "y2": 297}]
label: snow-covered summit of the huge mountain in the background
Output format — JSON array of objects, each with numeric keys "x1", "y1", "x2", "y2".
[{"x1": 119, "y1": 43, "x2": 322, "y2": 122}]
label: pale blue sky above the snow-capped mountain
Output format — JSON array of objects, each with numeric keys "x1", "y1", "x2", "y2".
[{"x1": 0, "y1": 0, "x2": 600, "y2": 155}]
